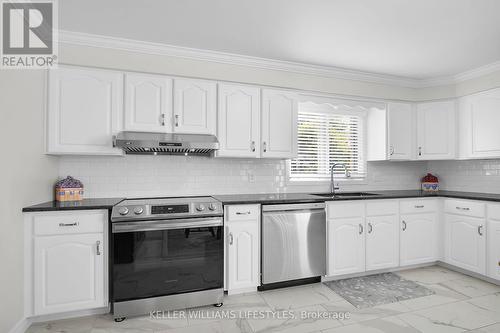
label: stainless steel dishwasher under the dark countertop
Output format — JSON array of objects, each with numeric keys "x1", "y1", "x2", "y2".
[{"x1": 262, "y1": 202, "x2": 326, "y2": 284}]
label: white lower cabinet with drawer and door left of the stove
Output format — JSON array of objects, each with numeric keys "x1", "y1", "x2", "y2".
[{"x1": 25, "y1": 210, "x2": 109, "y2": 317}]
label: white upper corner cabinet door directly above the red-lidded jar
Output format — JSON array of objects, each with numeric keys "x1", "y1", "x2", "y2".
[{"x1": 417, "y1": 101, "x2": 456, "y2": 160}]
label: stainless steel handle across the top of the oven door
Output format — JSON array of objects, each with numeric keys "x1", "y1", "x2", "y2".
[{"x1": 112, "y1": 217, "x2": 223, "y2": 234}]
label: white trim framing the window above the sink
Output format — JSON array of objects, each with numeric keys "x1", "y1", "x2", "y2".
[{"x1": 285, "y1": 97, "x2": 375, "y2": 186}]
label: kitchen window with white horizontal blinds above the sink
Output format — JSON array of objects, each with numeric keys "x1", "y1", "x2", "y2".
[{"x1": 289, "y1": 101, "x2": 368, "y2": 181}]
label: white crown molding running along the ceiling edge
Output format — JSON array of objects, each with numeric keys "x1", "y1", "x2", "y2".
[{"x1": 59, "y1": 30, "x2": 500, "y2": 88}]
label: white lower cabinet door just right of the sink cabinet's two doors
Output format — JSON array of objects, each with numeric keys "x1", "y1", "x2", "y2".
[{"x1": 400, "y1": 213, "x2": 438, "y2": 266}]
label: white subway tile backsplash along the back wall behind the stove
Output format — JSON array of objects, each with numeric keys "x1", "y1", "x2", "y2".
[{"x1": 59, "y1": 155, "x2": 427, "y2": 197}]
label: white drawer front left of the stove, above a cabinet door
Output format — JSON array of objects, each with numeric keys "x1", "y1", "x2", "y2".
[{"x1": 33, "y1": 210, "x2": 108, "y2": 235}]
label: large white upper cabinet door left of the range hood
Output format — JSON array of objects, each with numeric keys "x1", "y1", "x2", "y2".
[{"x1": 47, "y1": 66, "x2": 123, "y2": 155}]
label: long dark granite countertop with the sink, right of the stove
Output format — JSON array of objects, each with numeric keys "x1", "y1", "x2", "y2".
[{"x1": 213, "y1": 190, "x2": 500, "y2": 205}]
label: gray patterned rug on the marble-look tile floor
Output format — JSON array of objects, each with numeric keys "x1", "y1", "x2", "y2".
[{"x1": 323, "y1": 273, "x2": 434, "y2": 309}]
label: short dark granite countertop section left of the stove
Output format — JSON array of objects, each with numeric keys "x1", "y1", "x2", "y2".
[{"x1": 23, "y1": 198, "x2": 124, "y2": 213}]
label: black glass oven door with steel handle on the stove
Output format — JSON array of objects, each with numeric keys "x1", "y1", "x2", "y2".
[{"x1": 111, "y1": 217, "x2": 224, "y2": 302}]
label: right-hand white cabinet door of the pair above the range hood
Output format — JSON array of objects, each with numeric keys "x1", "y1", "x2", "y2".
[{"x1": 173, "y1": 79, "x2": 217, "y2": 135}]
